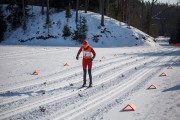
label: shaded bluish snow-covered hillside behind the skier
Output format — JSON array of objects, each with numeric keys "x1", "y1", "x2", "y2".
[{"x1": 1, "y1": 7, "x2": 156, "y2": 47}]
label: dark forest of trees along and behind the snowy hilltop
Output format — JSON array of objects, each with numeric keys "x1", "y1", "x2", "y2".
[{"x1": 0, "y1": 0, "x2": 180, "y2": 43}]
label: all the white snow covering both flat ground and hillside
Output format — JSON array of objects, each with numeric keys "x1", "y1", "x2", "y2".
[{"x1": 0, "y1": 7, "x2": 180, "y2": 120}]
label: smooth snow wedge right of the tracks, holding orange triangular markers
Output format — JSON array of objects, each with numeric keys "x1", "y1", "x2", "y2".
[{"x1": 104, "y1": 63, "x2": 180, "y2": 120}]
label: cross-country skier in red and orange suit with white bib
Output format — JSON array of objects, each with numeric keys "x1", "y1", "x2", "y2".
[{"x1": 76, "y1": 41, "x2": 96, "y2": 87}]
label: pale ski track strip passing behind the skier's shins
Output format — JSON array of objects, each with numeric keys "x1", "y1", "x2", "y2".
[{"x1": 0, "y1": 55, "x2": 146, "y2": 105}]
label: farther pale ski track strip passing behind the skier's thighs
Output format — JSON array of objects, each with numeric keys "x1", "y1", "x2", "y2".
[{"x1": 0, "y1": 56, "x2": 135, "y2": 93}]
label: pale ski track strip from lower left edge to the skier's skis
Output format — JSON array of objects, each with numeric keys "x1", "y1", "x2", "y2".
[{"x1": 0, "y1": 54, "x2": 162, "y2": 118}]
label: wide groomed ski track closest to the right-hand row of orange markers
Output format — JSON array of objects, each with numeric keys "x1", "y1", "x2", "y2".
[{"x1": 54, "y1": 55, "x2": 173, "y2": 120}]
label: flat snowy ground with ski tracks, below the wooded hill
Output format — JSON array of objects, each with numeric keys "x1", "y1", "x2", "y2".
[{"x1": 0, "y1": 45, "x2": 180, "y2": 120}]
